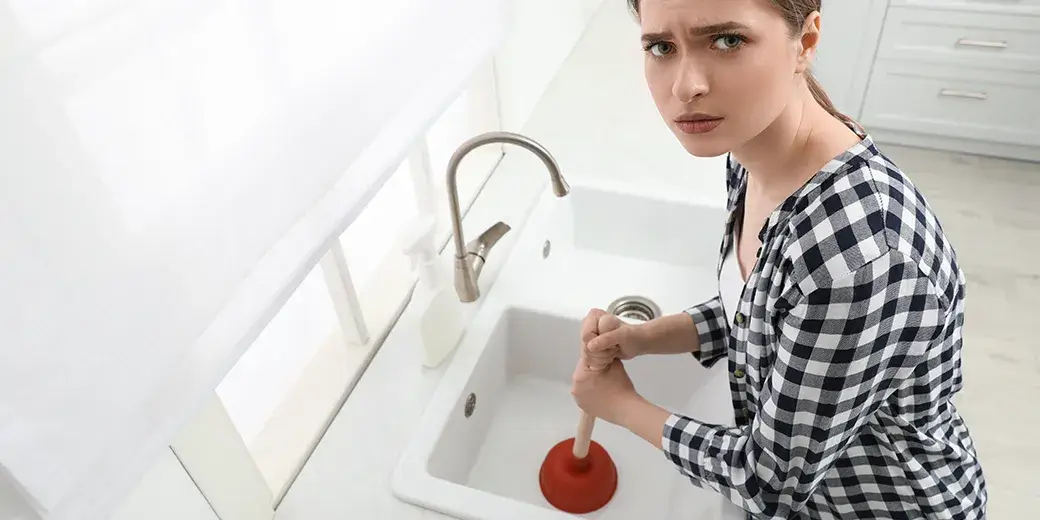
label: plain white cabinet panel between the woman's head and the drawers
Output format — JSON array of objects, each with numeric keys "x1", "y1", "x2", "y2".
[{"x1": 813, "y1": 0, "x2": 888, "y2": 120}]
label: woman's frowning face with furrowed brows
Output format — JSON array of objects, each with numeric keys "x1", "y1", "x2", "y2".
[{"x1": 640, "y1": 0, "x2": 806, "y2": 157}]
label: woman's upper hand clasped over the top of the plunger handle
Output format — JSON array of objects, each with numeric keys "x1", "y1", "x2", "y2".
[{"x1": 581, "y1": 309, "x2": 646, "y2": 368}]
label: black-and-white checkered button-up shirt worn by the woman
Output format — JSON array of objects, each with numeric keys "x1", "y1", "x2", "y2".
[{"x1": 661, "y1": 133, "x2": 987, "y2": 519}]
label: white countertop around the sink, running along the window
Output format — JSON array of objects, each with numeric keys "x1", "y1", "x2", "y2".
[{"x1": 276, "y1": 2, "x2": 725, "y2": 520}]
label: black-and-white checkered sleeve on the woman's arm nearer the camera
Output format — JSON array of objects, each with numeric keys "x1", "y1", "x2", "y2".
[{"x1": 661, "y1": 251, "x2": 946, "y2": 519}]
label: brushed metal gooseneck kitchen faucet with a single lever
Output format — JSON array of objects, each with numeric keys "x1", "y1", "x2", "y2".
[{"x1": 447, "y1": 132, "x2": 570, "y2": 303}]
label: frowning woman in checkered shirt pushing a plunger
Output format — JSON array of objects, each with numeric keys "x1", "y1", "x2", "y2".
[{"x1": 572, "y1": 0, "x2": 987, "y2": 519}]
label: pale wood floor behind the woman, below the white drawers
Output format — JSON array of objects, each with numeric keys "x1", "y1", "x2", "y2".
[{"x1": 881, "y1": 144, "x2": 1040, "y2": 519}]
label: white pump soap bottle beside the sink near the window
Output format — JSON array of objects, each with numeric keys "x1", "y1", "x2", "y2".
[{"x1": 405, "y1": 218, "x2": 463, "y2": 368}]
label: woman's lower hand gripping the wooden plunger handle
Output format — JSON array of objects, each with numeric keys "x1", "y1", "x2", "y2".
[{"x1": 571, "y1": 359, "x2": 639, "y2": 424}]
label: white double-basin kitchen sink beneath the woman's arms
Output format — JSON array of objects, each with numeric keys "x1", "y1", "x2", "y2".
[{"x1": 393, "y1": 186, "x2": 743, "y2": 520}]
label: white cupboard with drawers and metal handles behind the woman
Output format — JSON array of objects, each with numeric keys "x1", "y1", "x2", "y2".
[{"x1": 816, "y1": 0, "x2": 1040, "y2": 161}]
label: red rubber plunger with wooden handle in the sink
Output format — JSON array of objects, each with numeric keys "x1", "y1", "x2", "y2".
[{"x1": 538, "y1": 361, "x2": 618, "y2": 515}]
